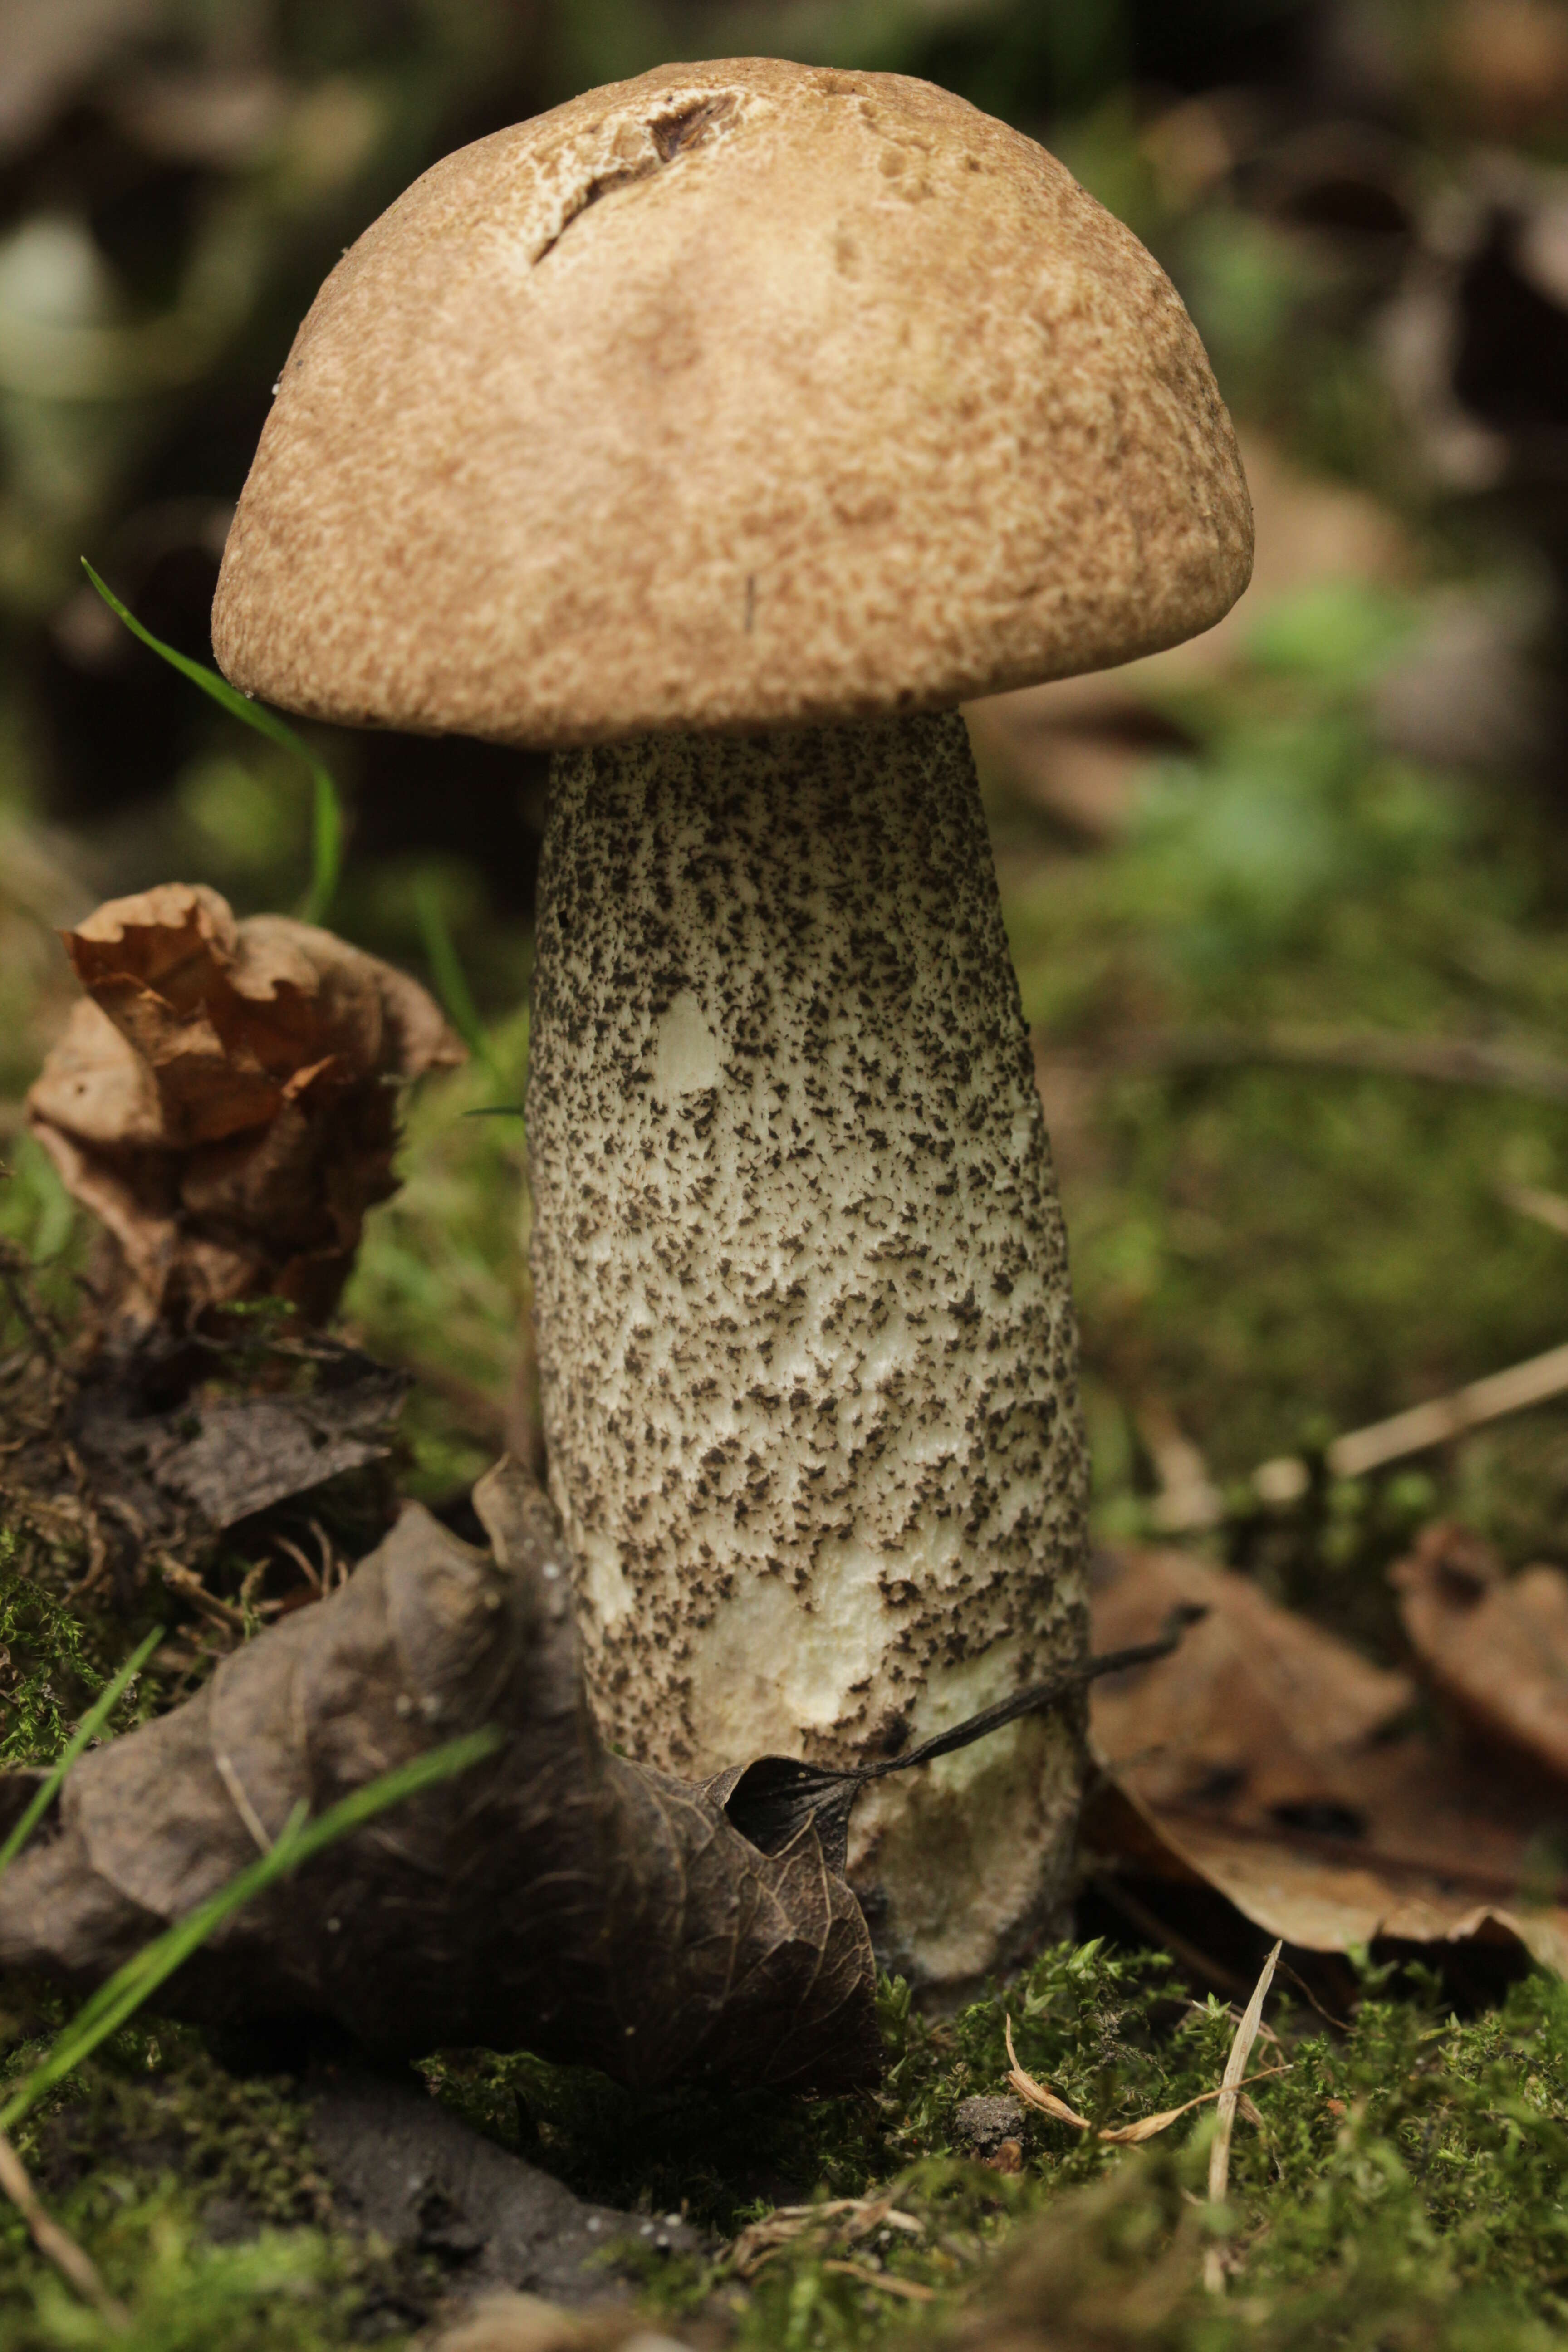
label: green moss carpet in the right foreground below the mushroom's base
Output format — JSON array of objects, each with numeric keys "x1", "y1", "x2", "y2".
[{"x1": 432, "y1": 1945, "x2": 1568, "y2": 2352}]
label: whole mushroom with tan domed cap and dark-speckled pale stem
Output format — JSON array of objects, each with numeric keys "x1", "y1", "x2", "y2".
[{"x1": 214, "y1": 59, "x2": 1251, "y2": 1987}]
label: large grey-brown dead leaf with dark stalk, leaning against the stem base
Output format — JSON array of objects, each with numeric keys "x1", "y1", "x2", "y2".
[{"x1": 0, "y1": 1463, "x2": 1173, "y2": 2091}]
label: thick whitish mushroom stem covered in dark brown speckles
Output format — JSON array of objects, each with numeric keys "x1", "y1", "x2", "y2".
[{"x1": 529, "y1": 715, "x2": 1084, "y2": 1985}]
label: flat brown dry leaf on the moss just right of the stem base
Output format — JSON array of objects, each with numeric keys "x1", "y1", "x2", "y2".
[{"x1": 1084, "y1": 1550, "x2": 1568, "y2": 1971}]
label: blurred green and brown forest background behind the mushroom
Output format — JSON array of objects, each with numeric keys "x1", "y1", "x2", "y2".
[{"x1": 0, "y1": 0, "x2": 1568, "y2": 1639}]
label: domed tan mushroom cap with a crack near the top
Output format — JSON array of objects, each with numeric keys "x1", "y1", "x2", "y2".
[{"x1": 214, "y1": 59, "x2": 1253, "y2": 745}]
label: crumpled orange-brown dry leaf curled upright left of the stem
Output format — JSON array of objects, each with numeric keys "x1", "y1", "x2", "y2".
[{"x1": 28, "y1": 882, "x2": 463, "y2": 1329}]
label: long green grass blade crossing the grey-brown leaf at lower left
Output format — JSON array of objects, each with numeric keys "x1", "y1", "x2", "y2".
[{"x1": 0, "y1": 1729, "x2": 501, "y2": 2131}]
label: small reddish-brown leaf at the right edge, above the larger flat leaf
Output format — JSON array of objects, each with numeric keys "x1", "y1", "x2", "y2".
[{"x1": 1389, "y1": 1522, "x2": 1568, "y2": 1780}]
